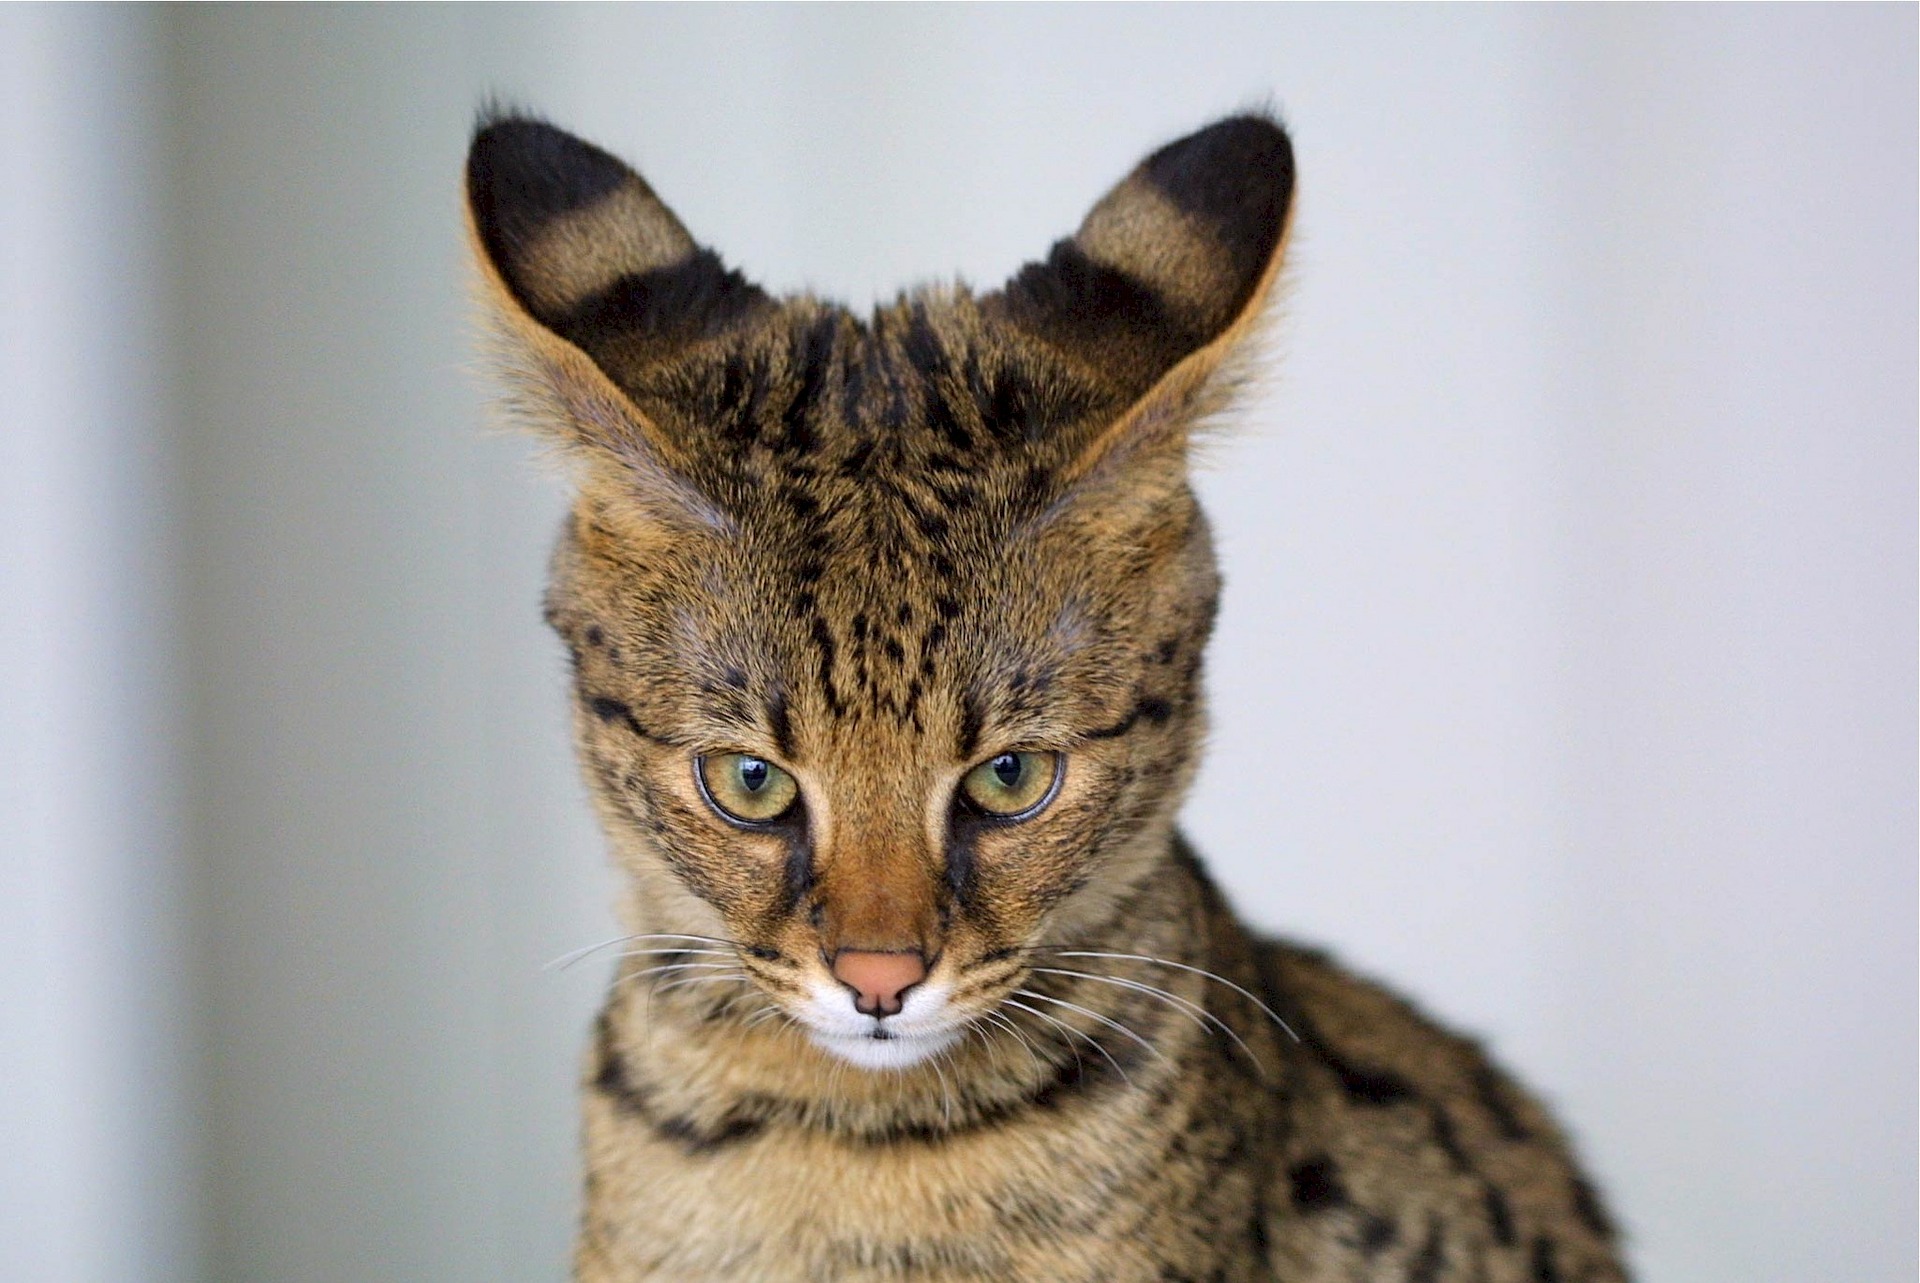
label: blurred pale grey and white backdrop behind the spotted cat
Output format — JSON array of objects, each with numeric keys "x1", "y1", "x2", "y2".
[{"x1": 0, "y1": 6, "x2": 1920, "y2": 1283}]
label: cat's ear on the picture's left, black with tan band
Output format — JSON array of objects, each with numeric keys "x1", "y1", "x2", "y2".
[{"x1": 467, "y1": 115, "x2": 756, "y2": 524}]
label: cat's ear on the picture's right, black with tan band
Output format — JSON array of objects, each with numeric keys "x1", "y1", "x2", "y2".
[{"x1": 985, "y1": 115, "x2": 1294, "y2": 480}]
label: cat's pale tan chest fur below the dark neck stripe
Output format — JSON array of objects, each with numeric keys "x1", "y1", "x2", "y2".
[{"x1": 580, "y1": 1102, "x2": 1252, "y2": 1283}]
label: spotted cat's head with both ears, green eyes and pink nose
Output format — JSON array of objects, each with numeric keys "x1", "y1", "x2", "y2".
[{"x1": 467, "y1": 115, "x2": 1292, "y2": 1066}]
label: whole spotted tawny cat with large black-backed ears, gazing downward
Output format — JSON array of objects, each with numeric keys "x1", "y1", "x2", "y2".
[{"x1": 467, "y1": 113, "x2": 1624, "y2": 1283}]
